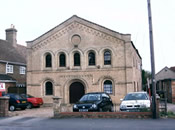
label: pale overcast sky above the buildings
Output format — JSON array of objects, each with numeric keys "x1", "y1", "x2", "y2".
[{"x1": 0, "y1": 0, "x2": 175, "y2": 72}]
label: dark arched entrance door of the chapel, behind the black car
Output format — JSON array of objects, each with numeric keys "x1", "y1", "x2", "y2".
[{"x1": 69, "y1": 82, "x2": 85, "y2": 103}]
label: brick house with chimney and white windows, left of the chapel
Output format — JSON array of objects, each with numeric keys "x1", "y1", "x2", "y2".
[{"x1": 0, "y1": 26, "x2": 26, "y2": 93}]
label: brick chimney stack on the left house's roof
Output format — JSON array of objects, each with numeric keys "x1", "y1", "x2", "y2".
[{"x1": 5, "y1": 24, "x2": 17, "y2": 47}]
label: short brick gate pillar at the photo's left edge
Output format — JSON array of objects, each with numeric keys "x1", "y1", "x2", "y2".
[{"x1": 0, "y1": 97, "x2": 9, "y2": 117}]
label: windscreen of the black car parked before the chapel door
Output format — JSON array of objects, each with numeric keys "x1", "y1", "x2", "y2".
[{"x1": 80, "y1": 94, "x2": 101, "y2": 102}]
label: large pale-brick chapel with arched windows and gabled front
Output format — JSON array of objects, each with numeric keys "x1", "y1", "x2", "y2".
[{"x1": 27, "y1": 15, "x2": 142, "y2": 106}]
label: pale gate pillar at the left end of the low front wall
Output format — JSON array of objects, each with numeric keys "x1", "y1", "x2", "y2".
[{"x1": 53, "y1": 97, "x2": 62, "y2": 117}]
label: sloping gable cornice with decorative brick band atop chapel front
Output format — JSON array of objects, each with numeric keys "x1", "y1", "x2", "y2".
[{"x1": 27, "y1": 15, "x2": 130, "y2": 50}]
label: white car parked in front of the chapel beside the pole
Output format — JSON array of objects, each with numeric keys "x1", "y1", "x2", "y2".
[{"x1": 120, "y1": 92, "x2": 151, "y2": 111}]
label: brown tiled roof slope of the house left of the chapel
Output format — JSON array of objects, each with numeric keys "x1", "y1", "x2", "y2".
[{"x1": 0, "y1": 40, "x2": 27, "y2": 64}]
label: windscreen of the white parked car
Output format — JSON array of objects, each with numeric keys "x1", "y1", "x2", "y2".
[{"x1": 124, "y1": 93, "x2": 148, "y2": 100}]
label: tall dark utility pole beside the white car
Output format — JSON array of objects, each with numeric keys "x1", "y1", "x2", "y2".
[{"x1": 147, "y1": 0, "x2": 157, "y2": 119}]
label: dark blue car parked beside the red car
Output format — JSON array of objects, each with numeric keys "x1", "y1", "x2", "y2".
[{"x1": 3, "y1": 93, "x2": 28, "y2": 111}]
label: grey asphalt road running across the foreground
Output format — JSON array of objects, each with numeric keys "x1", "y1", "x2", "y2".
[{"x1": 0, "y1": 116, "x2": 175, "y2": 130}]
